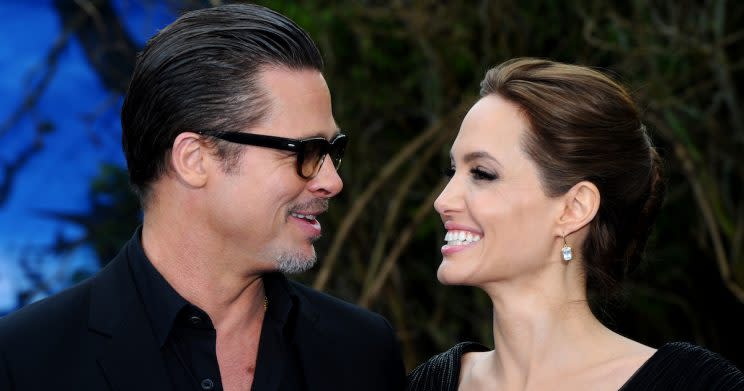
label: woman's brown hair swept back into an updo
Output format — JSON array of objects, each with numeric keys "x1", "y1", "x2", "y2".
[{"x1": 481, "y1": 58, "x2": 665, "y2": 304}]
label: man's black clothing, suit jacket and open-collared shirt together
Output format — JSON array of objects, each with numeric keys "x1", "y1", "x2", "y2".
[{"x1": 0, "y1": 230, "x2": 405, "y2": 391}]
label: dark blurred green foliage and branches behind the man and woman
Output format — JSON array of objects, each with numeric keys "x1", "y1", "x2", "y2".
[{"x1": 59, "y1": 0, "x2": 744, "y2": 368}]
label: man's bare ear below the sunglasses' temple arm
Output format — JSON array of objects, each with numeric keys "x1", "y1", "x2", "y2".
[{"x1": 171, "y1": 132, "x2": 209, "y2": 188}]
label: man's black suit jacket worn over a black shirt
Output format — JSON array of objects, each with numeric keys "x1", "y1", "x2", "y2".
[{"x1": 0, "y1": 240, "x2": 405, "y2": 391}]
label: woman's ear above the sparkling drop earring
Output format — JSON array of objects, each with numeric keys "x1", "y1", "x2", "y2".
[{"x1": 556, "y1": 181, "x2": 600, "y2": 236}]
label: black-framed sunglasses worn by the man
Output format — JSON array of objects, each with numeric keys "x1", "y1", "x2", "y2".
[{"x1": 198, "y1": 132, "x2": 347, "y2": 179}]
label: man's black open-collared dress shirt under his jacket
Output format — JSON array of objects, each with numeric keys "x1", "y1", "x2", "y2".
[{"x1": 130, "y1": 232, "x2": 305, "y2": 391}]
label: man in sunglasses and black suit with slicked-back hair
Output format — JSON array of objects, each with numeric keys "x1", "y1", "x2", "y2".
[{"x1": 0, "y1": 5, "x2": 404, "y2": 390}]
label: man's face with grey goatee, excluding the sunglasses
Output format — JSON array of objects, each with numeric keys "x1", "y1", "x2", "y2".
[{"x1": 207, "y1": 68, "x2": 343, "y2": 273}]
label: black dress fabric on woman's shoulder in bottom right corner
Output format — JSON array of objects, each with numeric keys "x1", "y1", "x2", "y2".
[{"x1": 621, "y1": 342, "x2": 744, "y2": 391}]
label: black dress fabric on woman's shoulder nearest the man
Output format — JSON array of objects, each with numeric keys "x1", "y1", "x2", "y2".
[{"x1": 406, "y1": 342, "x2": 490, "y2": 391}]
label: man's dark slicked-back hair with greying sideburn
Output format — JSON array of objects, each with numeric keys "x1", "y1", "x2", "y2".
[{"x1": 121, "y1": 4, "x2": 323, "y2": 205}]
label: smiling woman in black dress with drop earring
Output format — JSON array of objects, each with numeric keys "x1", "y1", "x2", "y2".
[{"x1": 408, "y1": 59, "x2": 744, "y2": 390}]
